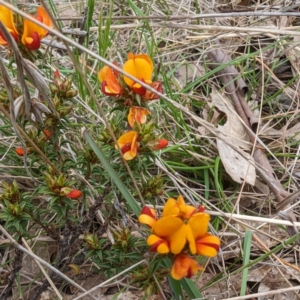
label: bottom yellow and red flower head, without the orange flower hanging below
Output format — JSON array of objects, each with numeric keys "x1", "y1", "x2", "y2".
[{"x1": 139, "y1": 196, "x2": 220, "y2": 257}]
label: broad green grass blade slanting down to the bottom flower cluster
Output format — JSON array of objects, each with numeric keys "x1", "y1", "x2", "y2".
[{"x1": 83, "y1": 131, "x2": 141, "y2": 216}]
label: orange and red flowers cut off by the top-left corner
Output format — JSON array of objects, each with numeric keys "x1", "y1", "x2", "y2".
[{"x1": 0, "y1": 5, "x2": 52, "y2": 50}]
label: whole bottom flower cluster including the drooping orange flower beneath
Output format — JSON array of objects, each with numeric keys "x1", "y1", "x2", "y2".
[{"x1": 139, "y1": 196, "x2": 220, "y2": 280}]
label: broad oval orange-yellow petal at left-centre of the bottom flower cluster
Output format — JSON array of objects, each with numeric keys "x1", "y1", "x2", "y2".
[{"x1": 152, "y1": 216, "x2": 183, "y2": 238}]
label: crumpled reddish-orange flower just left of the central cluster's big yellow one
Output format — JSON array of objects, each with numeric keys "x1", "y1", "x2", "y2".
[{"x1": 98, "y1": 66, "x2": 122, "y2": 96}]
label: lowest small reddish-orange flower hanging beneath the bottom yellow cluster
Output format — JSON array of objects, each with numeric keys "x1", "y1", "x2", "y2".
[{"x1": 171, "y1": 254, "x2": 204, "y2": 280}]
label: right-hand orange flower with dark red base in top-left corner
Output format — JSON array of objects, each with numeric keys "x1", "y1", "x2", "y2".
[{"x1": 22, "y1": 6, "x2": 52, "y2": 50}]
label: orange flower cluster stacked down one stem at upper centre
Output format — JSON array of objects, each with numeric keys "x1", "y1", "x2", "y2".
[{"x1": 98, "y1": 53, "x2": 168, "y2": 160}]
